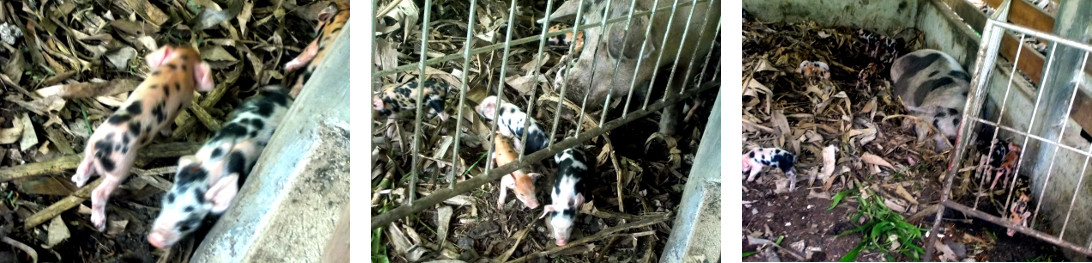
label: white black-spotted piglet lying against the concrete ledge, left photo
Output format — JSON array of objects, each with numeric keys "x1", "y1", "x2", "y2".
[{"x1": 147, "y1": 85, "x2": 292, "y2": 249}]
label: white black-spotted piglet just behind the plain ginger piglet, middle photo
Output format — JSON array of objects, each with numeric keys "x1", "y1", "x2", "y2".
[{"x1": 476, "y1": 96, "x2": 549, "y2": 154}]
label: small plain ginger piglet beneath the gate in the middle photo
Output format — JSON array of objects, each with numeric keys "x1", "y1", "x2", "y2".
[{"x1": 492, "y1": 134, "x2": 542, "y2": 210}]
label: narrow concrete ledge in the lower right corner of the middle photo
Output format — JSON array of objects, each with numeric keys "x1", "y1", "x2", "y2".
[{"x1": 660, "y1": 93, "x2": 723, "y2": 262}]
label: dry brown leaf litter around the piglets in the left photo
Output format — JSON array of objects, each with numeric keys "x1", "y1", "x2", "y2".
[{"x1": 0, "y1": 0, "x2": 336, "y2": 262}]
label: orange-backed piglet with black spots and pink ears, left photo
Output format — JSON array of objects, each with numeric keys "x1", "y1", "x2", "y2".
[{"x1": 72, "y1": 46, "x2": 214, "y2": 231}]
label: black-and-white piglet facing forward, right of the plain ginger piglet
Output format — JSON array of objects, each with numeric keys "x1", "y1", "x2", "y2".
[{"x1": 538, "y1": 148, "x2": 587, "y2": 247}]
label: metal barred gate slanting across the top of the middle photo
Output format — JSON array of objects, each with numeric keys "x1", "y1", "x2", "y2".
[{"x1": 369, "y1": 0, "x2": 721, "y2": 228}]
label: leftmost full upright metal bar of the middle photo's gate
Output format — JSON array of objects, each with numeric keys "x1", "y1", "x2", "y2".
[{"x1": 406, "y1": 0, "x2": 432, "y2": 204}]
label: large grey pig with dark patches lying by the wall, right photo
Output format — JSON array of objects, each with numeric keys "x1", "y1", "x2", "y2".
[{"x1": 891, "y1": 49, "x2": 971, "y2": 151}]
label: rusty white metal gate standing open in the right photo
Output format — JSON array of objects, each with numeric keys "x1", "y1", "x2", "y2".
[{"x1": 925, "y1": 1, "x2": 1092, "y2": 259}]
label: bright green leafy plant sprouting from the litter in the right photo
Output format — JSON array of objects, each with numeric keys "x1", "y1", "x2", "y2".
[{"x1": 839, "y1": 186, "x2": 926, "y2": 261}]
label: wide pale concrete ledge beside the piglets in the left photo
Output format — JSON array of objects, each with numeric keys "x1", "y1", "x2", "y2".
[{"x1": 191, "y1": 20, "x2": 352, "y2": 262}]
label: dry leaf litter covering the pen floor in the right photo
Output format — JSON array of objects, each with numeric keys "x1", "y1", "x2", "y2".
[{"x1": 743, "y1": 14, "x2": 1059, "y2": 261}]
